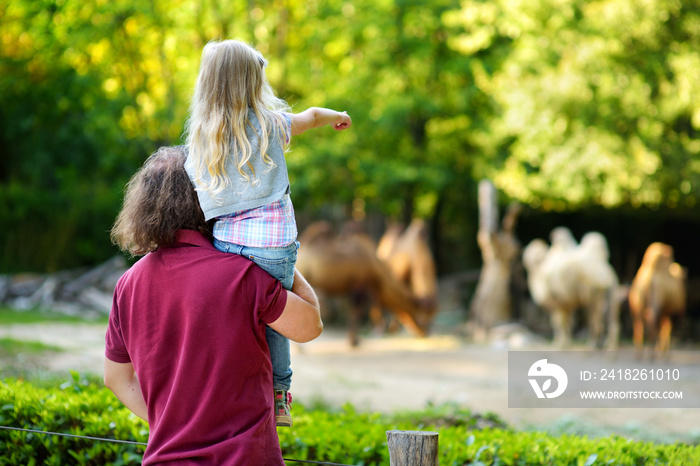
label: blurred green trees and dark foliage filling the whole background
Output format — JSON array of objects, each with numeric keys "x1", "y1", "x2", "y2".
[{"x1": 0, "y1": 0, "x2": 700, "y2": 339}]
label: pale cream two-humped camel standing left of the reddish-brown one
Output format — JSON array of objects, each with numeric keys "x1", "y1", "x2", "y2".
[{"x1": 523, "y1": 227, "x2": 620, "y2": 350}]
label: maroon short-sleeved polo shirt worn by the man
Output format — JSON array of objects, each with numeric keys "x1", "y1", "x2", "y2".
[{"x1": 105, "y1": 230, "x2": 287, "y2": 466}]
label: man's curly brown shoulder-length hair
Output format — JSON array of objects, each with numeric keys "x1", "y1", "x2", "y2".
[{"x1": 111, "y1": 146, "x2": 211, "y2": 256}]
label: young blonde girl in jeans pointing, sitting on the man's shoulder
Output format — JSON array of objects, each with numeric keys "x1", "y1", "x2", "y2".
[{"x1": 185, "y1": 40, "x2": 352, "y2": 426}]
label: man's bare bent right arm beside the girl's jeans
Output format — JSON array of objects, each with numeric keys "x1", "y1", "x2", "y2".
[{"x1": 268, "y1": 269, "x2": 323, "y2": 343}]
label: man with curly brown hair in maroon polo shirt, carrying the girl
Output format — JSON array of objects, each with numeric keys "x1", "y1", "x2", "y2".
[{"x1": 104, "y1": 147, "x2": 323, "y2": 465}]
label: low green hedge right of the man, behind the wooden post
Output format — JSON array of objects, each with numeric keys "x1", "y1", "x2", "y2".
[{"x1": 279, "y1": 405, "x2": 700, "y2": 466}]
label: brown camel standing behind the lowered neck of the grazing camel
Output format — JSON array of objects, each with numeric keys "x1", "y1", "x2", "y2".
[{"x1": 370, "y1": 219, "x2": 438, "y2": 329}]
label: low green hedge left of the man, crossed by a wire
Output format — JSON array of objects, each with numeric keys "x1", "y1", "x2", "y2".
[{"x1": 0, "y1": 373, "x2": 148, "y2": 466}]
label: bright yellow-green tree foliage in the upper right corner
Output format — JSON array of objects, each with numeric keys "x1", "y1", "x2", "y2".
[{"x1": 442, "y1": 0, "x2": 700, "y2": 210}]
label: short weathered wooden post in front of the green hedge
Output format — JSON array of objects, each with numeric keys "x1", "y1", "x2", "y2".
[{"x1": 386, "y1": 430, "x2": 438, "y2": 466}]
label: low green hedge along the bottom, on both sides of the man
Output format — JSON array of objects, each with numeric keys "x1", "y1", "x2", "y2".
[{"x1": 0, "y1": 373, "x2": 700, "y2": 466}]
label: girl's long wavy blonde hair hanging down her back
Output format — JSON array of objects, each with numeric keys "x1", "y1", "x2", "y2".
[{"x1": 185, "y1": 40, "x2": 289, "y2": 197}]
